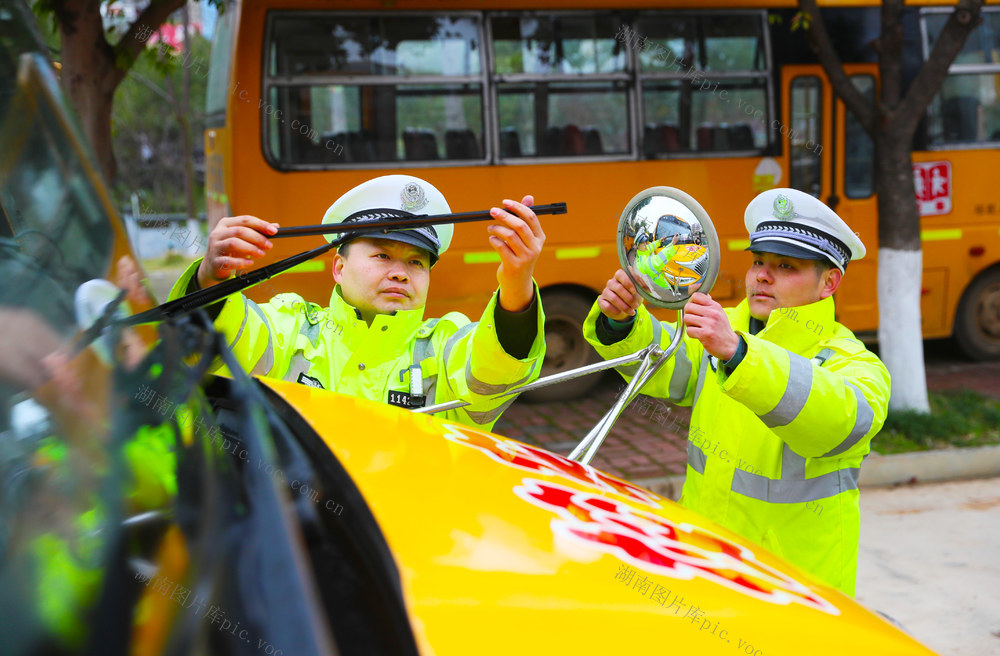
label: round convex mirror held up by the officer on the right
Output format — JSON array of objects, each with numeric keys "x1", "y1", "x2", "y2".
[{"x1": 618, "y1": 187, "x2": 719, "y2": 310}]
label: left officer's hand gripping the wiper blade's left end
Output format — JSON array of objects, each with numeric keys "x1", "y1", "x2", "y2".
[{"x1": 198, "y1": 214, "x2": 278, "y2": 288}]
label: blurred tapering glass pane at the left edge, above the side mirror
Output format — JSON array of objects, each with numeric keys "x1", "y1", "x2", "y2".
[{"x1": 0, "y1": 56, "x2": 113, "y2": 334}]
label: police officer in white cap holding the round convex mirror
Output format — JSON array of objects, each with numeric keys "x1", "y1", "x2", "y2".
[{"x1": 584, "y1": 189, "x2": 889, "y2": 594}]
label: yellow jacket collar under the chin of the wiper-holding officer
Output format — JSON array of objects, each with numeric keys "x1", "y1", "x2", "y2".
[{"x1": 330, "y1": 285, "x2": 424, "y2": 357}]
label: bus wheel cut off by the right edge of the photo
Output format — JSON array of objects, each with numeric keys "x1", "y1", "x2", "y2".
[{"x1": 955, "y1": 269, "x2": 1000, "y2": 360}]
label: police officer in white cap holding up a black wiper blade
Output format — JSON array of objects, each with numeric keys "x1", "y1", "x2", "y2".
[{"x1": 170, "y1": 175, "x2": 545, "y2": 429}]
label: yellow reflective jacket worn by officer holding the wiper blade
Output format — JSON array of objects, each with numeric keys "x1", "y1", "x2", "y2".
[{"x1": 169, "y1": 260, "x2": 545, "y2": 430}]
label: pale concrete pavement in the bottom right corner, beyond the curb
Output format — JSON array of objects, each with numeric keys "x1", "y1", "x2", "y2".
[{"x1": 857, "y1": 478, "x2": 1000, "y2": 656}]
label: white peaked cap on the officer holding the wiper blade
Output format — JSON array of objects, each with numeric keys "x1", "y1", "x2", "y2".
[{"x1": 323, "y1": 175, "x2": 455, "y2": 264}]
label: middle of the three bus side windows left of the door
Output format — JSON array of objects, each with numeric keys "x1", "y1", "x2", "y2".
[{"x1": 490, "y1": 13, "x2": 630, "y2": 159}]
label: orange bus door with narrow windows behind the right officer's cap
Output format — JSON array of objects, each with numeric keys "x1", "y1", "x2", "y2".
[{"x1": 770, "y1": 64, "x2": 878, "y2": 332}]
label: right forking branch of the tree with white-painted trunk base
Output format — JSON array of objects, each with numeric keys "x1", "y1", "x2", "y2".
[{"x1": 897, "y1": 0, "x2": 983, "y2": 134}]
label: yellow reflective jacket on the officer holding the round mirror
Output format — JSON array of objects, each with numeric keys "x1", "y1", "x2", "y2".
[{"x1": 584, "y1": 298, "x2": 889, "y2": 595}]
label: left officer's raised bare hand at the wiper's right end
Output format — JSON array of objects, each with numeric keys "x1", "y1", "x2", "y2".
[{"x1": 486, "y1": 196, "x2": 545, "y2": 312}]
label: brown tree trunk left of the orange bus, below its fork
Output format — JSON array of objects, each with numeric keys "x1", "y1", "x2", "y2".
[{"x1": 57, "y1": 0, "x2": 123, "y2": 181}]
